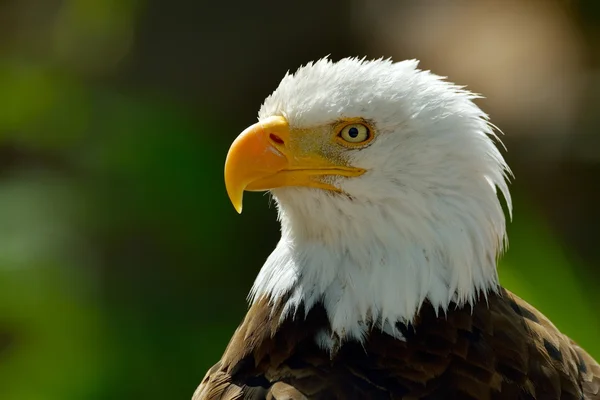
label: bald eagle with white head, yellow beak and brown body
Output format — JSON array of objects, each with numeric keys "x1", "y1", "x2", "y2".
[{"x1": 193, "y1": 58, "x2": 600, "y2": 400}]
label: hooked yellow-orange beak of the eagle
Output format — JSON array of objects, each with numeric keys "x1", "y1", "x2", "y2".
[{"x1": 225, "y1": 116, "x2": 365, "y2": 213}]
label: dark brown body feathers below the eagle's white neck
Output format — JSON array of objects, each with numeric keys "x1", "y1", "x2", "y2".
[{"x1": 193, "y1": 290, "x2": 600, "y2": 400}]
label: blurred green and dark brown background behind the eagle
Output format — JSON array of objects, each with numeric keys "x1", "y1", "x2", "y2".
[{"x1": 0, "y1": 0, "x2": 600, "y2": 400}]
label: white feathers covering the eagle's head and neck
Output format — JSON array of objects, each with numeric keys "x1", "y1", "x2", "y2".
[{"x1": 246, "y1": 58, "x2": 512, "y2": 347}]
